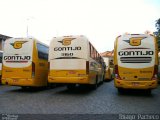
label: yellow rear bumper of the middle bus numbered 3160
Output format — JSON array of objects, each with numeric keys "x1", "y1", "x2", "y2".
[{"x1": 48, "y1": 76, "x2": 90, "y2": 84}]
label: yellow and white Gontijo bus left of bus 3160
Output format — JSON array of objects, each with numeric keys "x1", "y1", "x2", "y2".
[{"x1": 2, "y1": 38, "x2": 49, "y2": 88}]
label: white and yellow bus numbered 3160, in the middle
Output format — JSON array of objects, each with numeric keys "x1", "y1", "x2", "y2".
[{"x1": 48, "y1": 36, "x2": 105, "y2": 89}]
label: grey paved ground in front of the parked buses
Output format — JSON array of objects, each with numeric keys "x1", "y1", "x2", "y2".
[{"x1": 0, "y1": 81, "x2": 160, "y2": 119}]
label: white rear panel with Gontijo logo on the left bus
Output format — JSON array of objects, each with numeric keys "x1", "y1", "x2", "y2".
[{"x1": 3, "y1": 38, "x2": 33, "y2": 68}]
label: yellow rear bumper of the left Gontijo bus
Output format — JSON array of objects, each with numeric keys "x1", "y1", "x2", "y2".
[{"x1": 2, "y1": 78, "x2": 36, "y2": 86}]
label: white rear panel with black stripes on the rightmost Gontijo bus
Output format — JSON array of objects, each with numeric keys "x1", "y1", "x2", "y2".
[{"x1": 117, "y1": 35, "x2": 155, "y2": 68}]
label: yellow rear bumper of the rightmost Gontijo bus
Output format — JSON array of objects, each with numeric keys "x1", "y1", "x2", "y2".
[{"x1": 114, "y1": 79, "x2": 158, "y2": 89}]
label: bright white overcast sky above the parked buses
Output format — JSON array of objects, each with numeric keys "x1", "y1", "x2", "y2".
[{"x1": 0, "y1": 0, "x2": 160, "y2": 52}]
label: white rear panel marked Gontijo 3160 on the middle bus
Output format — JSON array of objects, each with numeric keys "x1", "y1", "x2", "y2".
[{"x1": 49, "y1": 36, "x2": 88, "y2": 70}]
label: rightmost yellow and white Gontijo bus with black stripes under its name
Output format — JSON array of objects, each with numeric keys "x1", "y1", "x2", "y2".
[{"x1": 114, "y1": 34, "x2": 158, "y2": 93}]
